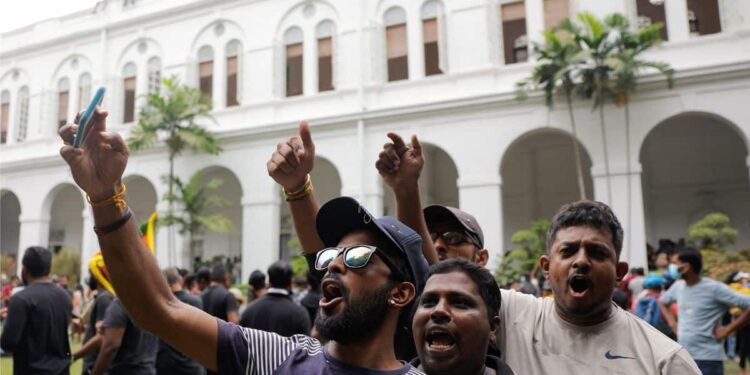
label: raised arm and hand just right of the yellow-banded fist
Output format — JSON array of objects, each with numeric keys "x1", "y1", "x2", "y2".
[{"x1": 375, "y1": 133, "x2": 439, "y2": 264}]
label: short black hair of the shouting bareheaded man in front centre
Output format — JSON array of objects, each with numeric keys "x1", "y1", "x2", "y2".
[{"x1": 427, "y1": 258, "x2": 502, "y2": 325}]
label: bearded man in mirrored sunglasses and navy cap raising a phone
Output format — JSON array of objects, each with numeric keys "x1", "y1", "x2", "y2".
[{"x1": 60, "y1": 110, "x2": 427, "y2": 374}]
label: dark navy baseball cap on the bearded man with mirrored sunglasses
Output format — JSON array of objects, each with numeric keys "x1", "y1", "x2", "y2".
[{"x1": 315, "y1": 197, "x2": 428, "y2": 295}]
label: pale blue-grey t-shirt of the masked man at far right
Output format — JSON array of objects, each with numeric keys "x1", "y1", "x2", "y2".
[{"x1": 661, "y1": 277, "x2": 750, "y2": 361}]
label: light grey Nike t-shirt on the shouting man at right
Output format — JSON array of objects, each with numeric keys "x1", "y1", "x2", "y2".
[{"x1": 498, "y1": 290, "x2": 700, "y2": 375}]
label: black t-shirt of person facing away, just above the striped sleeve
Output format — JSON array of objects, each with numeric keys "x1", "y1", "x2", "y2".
[{"x1": 240, "y1": 293, "x2": 310, "y2": 337}]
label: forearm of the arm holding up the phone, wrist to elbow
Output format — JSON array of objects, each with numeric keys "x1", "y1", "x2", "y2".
[{"x1": 93, "y1": 201, "x2": 174, "y2": 331}]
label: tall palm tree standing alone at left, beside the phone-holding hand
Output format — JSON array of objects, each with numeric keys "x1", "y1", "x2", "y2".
[{"x1": 128, "y1": 77, "x2": 222, "y2": 263}]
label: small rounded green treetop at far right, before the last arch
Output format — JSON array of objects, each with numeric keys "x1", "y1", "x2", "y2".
[{"x1": 688, "y1": 212, "x2": 738, "y2": 251}]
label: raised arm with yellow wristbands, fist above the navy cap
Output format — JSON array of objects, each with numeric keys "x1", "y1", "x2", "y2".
[{"x1": 266, "y1": 121, "x2": 324, "y2": 254}]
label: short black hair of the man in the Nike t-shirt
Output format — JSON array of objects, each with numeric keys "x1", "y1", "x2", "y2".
[{"x1": 547, "y1": 200, "x2": 623, "y2": 259}]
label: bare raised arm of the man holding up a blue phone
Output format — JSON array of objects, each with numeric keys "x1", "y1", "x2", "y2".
[{"x1": 60, "y1": 110, "x2": 218, "y2": 370}]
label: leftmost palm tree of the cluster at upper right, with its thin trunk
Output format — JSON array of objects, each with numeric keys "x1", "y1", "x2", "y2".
[{"x1": 516, "y1": 20, "x2": 586, "y2": 203}]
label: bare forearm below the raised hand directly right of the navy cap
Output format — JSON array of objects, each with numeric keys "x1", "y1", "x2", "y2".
[{"x1": 393, "y1": 184, "x2": 439, "y2": 264}]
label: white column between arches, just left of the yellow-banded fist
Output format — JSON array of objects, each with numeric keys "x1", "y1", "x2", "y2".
[{"x1": 242, "y1": 195, "x2": 286, "y2": 282}]
